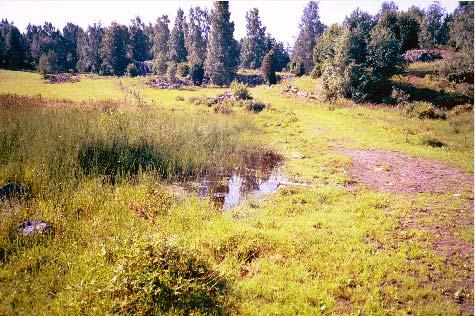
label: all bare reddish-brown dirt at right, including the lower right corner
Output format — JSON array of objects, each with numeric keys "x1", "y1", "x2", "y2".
[{"x1": 337, "y1": 148, "x2": 474, "y2": 315}]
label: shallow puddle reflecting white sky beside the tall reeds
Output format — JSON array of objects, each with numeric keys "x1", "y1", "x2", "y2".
[{"x1": 185, "y1": 153, "x2": 287, "y2": 210}]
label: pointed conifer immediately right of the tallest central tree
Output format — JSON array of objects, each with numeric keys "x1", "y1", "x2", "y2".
[{"x1": 240, "y1": 8, "x2": 268, "y2": 69}]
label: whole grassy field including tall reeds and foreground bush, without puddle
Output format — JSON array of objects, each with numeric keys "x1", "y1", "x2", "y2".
[{"x1": 0, "y1": 70, "x2": 474, "y2": 315}]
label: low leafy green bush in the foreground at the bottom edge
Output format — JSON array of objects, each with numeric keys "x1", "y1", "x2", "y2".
[{"x1": 109, "y1": 240, "x2": 231, "y2": 315}]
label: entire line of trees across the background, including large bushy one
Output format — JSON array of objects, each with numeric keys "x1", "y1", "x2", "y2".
[{"x1": 0, "y1": 1, "x2": 473, "y2": 100}]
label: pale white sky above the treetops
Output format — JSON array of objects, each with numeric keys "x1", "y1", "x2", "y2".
[{"x1": 0, "y1": 0, "x2": 458, "y2": 45}]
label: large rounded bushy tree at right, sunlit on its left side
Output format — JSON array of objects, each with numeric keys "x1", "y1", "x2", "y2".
[{"x1": 322, "y1": 21, "x2": 402, "y2": 102}]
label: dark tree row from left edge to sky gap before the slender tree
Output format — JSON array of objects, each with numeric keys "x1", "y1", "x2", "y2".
[{"x1": 0, "y1": 1, "x2": 290, "y2": 85}]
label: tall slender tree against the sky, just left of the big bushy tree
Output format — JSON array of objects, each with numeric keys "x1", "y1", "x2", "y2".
[{"x1": 292, "y1": 1, "x2": 325, "y2": 73}]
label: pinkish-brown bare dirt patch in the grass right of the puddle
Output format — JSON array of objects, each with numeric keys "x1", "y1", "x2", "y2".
[{"x1": 337, "y1": 148, "x2": 473, "y2": 194}]
